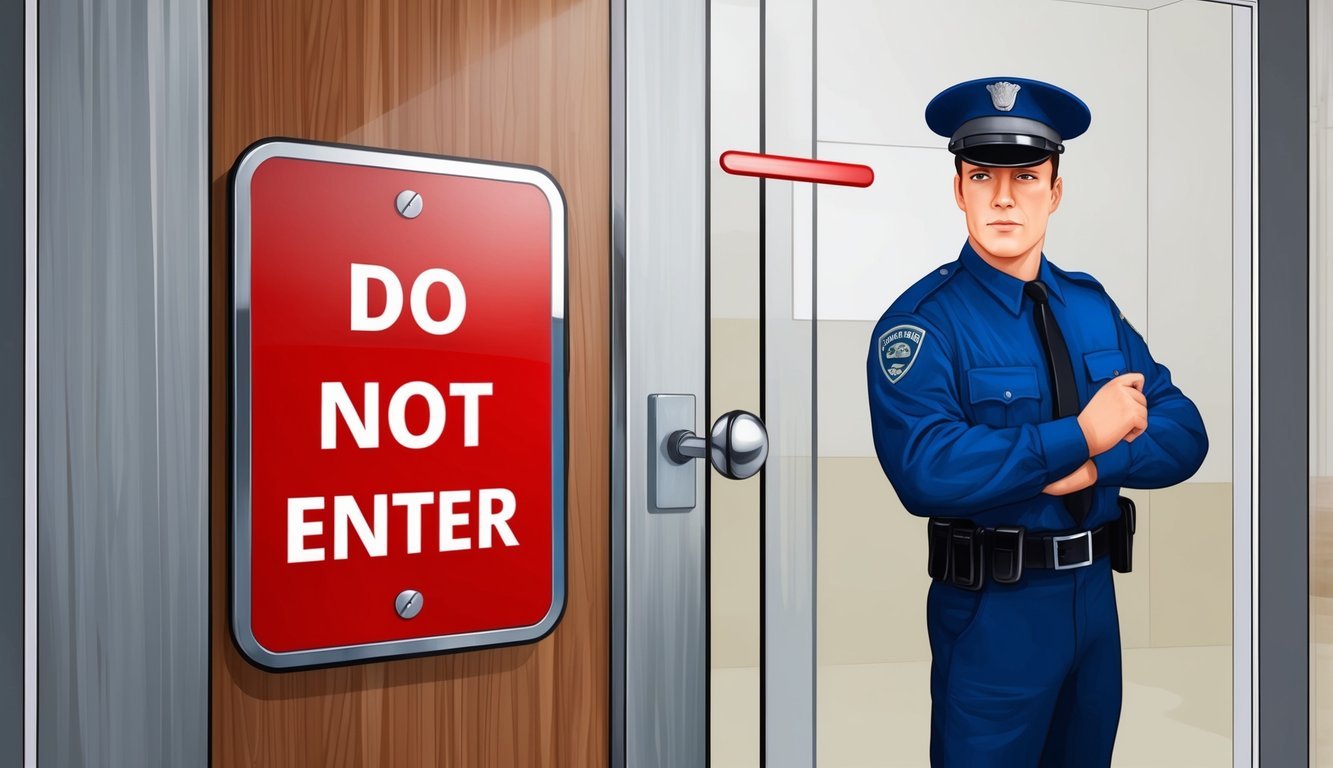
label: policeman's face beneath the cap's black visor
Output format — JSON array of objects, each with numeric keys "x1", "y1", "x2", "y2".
[{"x1": 953, "y1": 159, "x2": 1064, "y2": 259}]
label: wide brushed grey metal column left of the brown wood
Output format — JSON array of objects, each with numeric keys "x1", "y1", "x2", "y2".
[{"x1": 36, "y1": 0, "x2": 209, "y2": 768}]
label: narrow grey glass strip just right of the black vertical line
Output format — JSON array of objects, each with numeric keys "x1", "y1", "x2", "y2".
[{"x1": 760, "y1": 0, "x2": 818, "y2": 768}]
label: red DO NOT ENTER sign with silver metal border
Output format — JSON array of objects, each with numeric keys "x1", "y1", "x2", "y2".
[{"x1": 232, "y1": 141, "x2": 565, "y2": 668}]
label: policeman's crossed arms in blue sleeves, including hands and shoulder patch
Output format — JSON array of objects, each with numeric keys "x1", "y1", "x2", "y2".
[{"x1": 866, "y1": 308, "x2": 1208, "y2": 516}]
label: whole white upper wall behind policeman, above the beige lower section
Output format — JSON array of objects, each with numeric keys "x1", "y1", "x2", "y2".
[{"x1": 793, "y1": 0, "x2": 1241, "y2": 483}]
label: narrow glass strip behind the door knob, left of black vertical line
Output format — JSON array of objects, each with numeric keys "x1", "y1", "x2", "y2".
[{"x1": 706, "y1": 0, "x2": 761, "y2": 768}]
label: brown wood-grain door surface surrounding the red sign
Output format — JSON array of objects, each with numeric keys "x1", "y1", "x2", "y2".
[{"x1": 211, "y1": 0, "x2": 609, "y2": 768}]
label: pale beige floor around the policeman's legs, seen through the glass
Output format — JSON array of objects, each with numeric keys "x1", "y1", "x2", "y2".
[{"x1": 712, "y1": 645, "x2": 1231, "y2": 768}]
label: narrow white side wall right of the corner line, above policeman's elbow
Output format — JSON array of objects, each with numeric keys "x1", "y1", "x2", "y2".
[{"x1": 1141, "y1": 0, "x2": 1231, "y2": 483}]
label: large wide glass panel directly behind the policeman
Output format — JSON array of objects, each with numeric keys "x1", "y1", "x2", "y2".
[{"x1": 796, "y1": 0, "x2": 1244, "y2": 767}]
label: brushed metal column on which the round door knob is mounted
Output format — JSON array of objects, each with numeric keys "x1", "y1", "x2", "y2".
[{"x1": 612, "y1": 0, "x2": 708, "y2": 768}]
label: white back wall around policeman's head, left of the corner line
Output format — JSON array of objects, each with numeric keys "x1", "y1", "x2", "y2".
[{"x1": 797, "y1": 0, "x2": 1148, "y2": 323}]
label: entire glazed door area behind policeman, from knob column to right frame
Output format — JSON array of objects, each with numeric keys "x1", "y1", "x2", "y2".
[{"x1": 706, "y1": 0, "x2": 1253, "y2": 767}]
